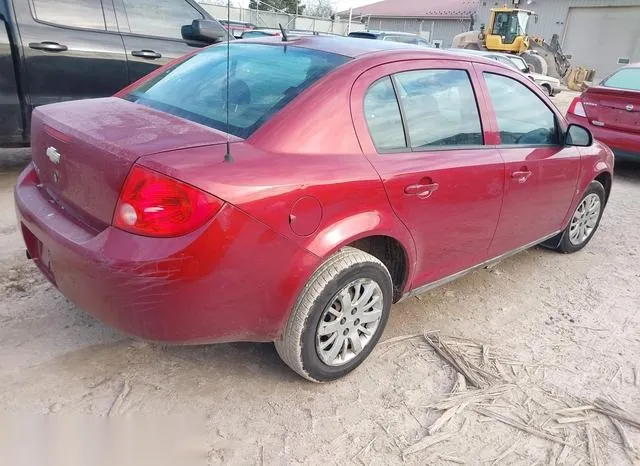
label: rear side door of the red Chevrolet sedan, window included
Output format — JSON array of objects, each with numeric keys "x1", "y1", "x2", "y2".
[{"x1": 351, "y1": 60, "x2": 504, "y2": 288}]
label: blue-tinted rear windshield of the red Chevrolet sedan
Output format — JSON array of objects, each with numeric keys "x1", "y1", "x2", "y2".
[{"x1": 126, "y1": 43, "x2": 349, "y2": 138}]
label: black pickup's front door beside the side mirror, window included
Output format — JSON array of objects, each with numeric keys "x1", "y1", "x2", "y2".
[{"x1": 113, "y1": 0, "x2": 204, "y2": 82}]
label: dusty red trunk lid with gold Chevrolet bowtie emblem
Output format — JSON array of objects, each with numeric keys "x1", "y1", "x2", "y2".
[{"x1": 31, "y1": 98, "x2": 227, "y2": 231}]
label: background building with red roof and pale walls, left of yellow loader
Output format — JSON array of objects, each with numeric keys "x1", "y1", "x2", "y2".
[{"x1": 338, "y1": 0, "x2": 480, "y2": 47}]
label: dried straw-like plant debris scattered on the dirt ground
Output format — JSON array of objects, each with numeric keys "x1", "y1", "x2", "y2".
[{"x1": 396, "y1": 333, "x2": 640, "y2": 465}]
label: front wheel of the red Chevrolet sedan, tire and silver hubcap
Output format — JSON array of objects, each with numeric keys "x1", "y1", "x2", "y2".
[{"x1": 557, "y1": 181, "x2": 606, "y2": 254}]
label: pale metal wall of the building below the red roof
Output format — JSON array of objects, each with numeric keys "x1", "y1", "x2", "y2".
[{"x1": 366, "y1": 18, "x2": 470, "y2": 47}]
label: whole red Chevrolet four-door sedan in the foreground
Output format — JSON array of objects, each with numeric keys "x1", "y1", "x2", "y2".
[{"x1": 15, "y1": 37, "x2": 613, "y2": 381}]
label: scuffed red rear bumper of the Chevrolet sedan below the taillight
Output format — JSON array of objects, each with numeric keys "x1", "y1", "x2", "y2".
[{"x1": 15, "y1": 165, "x2": 318, "y2": 344}]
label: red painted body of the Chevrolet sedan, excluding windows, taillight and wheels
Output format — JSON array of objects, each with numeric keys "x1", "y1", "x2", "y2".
[{"x1": 16, "y1": 37, "x2": 613, "y2": 343}]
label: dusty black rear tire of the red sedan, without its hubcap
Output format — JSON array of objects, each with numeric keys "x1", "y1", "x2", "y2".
[{"x1": 275, "y1": 247, "x2": 393, "y2": 383}]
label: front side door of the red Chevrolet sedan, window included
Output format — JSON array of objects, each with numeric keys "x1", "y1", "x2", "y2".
[{"x1": 475, "y1": 64, "x2": 580, "y2": 256}]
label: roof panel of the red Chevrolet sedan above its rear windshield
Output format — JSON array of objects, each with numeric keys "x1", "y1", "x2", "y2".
[{"x1": 243, "y1": 35, "x2": 452, "y2": 59}]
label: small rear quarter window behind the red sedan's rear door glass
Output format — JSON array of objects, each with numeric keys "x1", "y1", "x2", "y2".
[{"x1": 364, "y1": 76, "x2": 407, "y2": 152}]
